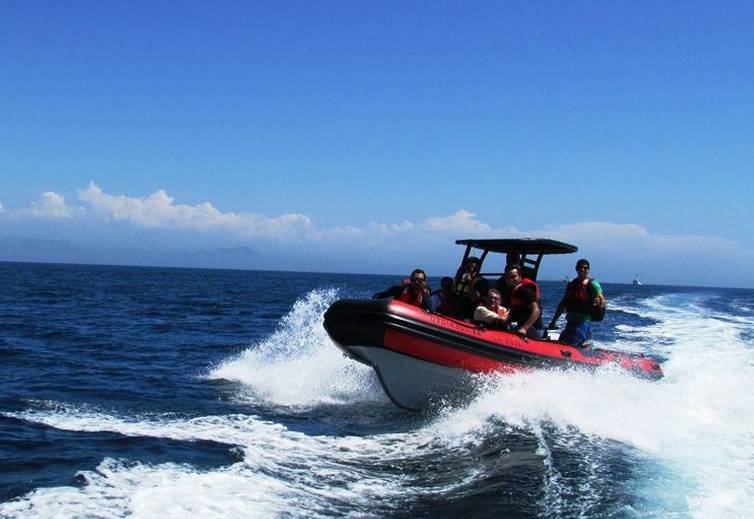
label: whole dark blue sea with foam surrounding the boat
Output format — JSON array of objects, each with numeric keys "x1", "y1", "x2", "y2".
[{"x1": 0, "y1": 263, "x2": 754, "y2": 519}]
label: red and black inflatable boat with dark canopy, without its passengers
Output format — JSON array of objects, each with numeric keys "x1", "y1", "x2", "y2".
[{"x1": 324, "y1": 240, "x2": 662, "y2": 410}]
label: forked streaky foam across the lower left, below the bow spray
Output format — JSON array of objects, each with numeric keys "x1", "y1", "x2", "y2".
[{"x1": 0, "y1": 405, "x2": 488, "y2": 518}]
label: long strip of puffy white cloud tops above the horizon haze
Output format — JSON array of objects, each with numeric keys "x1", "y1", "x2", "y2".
[{"x1": 72, "y1": 182, "x2": 743, "y2": 264}]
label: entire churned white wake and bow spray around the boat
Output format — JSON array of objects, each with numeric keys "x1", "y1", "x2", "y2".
[{"x1": 0, "y1": 290, "x2": 754, "y2": 517}]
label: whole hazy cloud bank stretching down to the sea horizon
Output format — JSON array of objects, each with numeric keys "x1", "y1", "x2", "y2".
[{"x1": 0, "y1": 182, "x2": 754, "y2": 286}]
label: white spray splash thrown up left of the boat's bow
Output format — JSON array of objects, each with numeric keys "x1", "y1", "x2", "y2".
[{"x1": 208, "y1": 289, "x2": 386, "y2": 407}]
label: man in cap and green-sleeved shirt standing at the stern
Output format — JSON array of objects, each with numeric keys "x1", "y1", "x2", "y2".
[{"x1": 548, "y1": 258, "x2": 607, "y2": 346}]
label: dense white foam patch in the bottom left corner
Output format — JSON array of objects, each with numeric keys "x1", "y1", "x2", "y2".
[{"x1": 0, "y1": 459, "x2": 314, "y2": 518}]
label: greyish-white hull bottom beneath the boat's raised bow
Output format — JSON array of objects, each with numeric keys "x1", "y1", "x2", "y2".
[{"x1": 350, "y1": 346, "x2": 474, "y2": 410}]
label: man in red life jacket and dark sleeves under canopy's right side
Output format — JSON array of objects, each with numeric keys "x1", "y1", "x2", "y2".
[{"x1": 501, "y1": 264, "x2": 544, "y2": 339}]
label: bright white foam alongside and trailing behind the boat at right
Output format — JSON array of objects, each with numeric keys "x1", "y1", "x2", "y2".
[{"x1": 426, "y1": 297, "x2": 754, "y2": 517}]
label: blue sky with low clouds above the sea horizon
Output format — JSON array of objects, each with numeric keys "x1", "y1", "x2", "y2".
[{"x1": 0, "y1": 1, "x2": 754, "y2": 287}]
